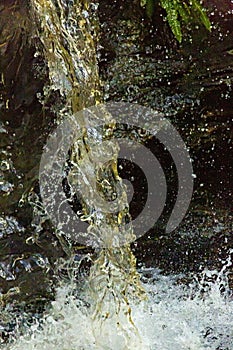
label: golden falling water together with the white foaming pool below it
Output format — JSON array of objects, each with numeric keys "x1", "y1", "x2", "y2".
[{"x1": 2, "y1": 0, "x2": 233, "y2": 350}]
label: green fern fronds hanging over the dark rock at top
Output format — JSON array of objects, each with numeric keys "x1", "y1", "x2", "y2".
[{"x1": 141, "y1": 0, "x2": 211, "y2": 42}]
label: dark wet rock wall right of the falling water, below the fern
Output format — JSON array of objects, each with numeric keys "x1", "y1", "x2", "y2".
[{"x1": 99, "y1": 1, "x2": 233, "y2": 272}]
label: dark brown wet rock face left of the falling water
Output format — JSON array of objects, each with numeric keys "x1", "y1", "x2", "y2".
[{"x1": 0, "y1": 1, "x2": 63, "y2": 299}]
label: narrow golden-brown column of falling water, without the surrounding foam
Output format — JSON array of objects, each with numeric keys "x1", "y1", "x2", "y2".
[{"x1": 31, "y1": 0, "x2": 145, "y2": 349}]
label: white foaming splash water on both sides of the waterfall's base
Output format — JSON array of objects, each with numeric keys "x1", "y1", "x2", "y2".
[{"x1": 3, "y1": 252, "x2": 233, "y2": 350}]
